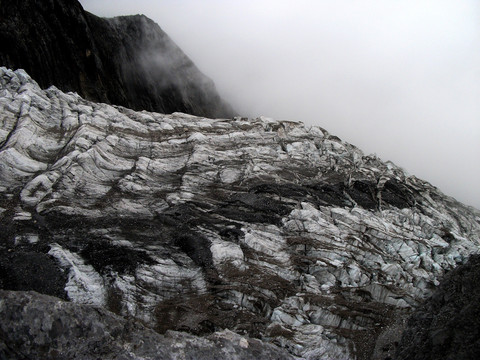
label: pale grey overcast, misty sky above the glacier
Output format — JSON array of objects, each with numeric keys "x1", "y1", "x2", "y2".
[{"x1": 80, "y1": 0, "x2": 480, "y2": 208}]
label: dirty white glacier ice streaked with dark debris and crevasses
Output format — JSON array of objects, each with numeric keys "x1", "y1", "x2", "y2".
[{"x1": 0, "y1": 68, "x2": 480, "y2": 359}]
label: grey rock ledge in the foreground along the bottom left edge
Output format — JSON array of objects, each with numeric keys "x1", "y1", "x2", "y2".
[{"x1": 0, "y1": 291, "x2": 293, "y2": 360}]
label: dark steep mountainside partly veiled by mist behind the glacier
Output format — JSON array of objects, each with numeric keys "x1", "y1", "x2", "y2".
[{"x1": 0, "y1": 0, "x2": 234, "y2": 117}]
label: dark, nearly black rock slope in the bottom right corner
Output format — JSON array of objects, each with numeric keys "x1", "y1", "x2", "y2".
[{"x1": 396, "y1": 255, "x2": 480, "y2": 360}]
